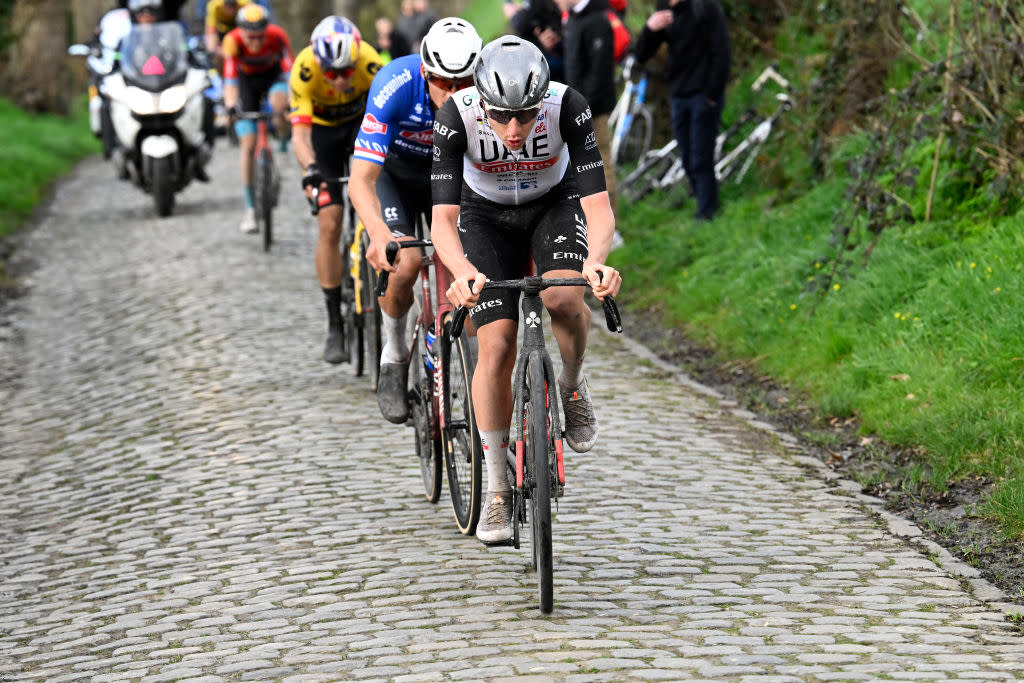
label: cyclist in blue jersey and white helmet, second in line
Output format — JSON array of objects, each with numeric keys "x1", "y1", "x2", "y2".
[{"x1": 348, "y1": 16, "x2": 483, "y2": 424}]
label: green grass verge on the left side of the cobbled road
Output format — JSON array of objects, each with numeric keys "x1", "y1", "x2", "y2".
[{"x1": 0, "y1": 97, "x2": 100, "y2": 237}]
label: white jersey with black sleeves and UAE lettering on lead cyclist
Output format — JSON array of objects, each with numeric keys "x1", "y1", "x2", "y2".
[{"x1": 431, "y1": 82, "x2": 605, "y2": 205}]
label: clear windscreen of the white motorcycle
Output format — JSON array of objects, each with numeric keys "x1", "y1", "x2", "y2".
[{"x1": 121, "y1": 22, "x2": 188, "y2": 92}]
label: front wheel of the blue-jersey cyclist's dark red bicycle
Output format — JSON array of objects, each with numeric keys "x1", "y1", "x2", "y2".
[{"x1": 440, "y1": 313, "x2": 483, "y2": 536}]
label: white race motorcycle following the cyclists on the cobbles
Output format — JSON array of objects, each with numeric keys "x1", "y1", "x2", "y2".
[{"x1": 73, "y1": 22, "x2": 211, "y2": 216}]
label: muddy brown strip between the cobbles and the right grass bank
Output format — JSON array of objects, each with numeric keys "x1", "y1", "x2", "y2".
[{"x1": 629, "y1": 303, "x2": 1024, "y2": 605}]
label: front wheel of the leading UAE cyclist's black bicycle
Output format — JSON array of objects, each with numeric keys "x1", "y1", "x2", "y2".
[{"x1": 523, "y1": 354, "x2": 554, "y2": 614}]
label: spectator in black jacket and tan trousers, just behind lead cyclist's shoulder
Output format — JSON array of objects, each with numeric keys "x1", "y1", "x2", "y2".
[{"x1": 556, "y1": 0, "x2": 618, "y2": 216}]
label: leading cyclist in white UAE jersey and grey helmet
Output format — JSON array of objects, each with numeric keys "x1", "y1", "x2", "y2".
[{"x1": 431, "y1": 36, "x2": 622, "y2": 543}]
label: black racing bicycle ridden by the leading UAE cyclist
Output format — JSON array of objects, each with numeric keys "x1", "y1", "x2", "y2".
[{"x1": 449, "y1": 275, "x2": 623, "y2": 613}]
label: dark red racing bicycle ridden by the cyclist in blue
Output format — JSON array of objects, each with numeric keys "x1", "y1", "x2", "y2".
[{"x1": 377, "y1": 236, "x2": 483, "y2": 536}]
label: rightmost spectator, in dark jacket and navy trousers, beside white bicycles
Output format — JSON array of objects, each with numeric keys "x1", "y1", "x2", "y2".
[{"x1": 636, "y1": 0, "x2": 731, "y2": 219}]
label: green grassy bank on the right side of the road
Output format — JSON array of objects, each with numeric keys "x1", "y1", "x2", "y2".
[{"x1": 612, "y1": 138, "x2": 1024, "y2": 535}]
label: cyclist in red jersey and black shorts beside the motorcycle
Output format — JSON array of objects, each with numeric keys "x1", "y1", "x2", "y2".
[{"x1": 221, "y1": 3, "x2": 292, "y2": 232}]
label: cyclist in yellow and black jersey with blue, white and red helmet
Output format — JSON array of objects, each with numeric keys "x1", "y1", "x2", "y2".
[{"x1": 291, "y1": 15, "x2": 383, "y2": 364}]
